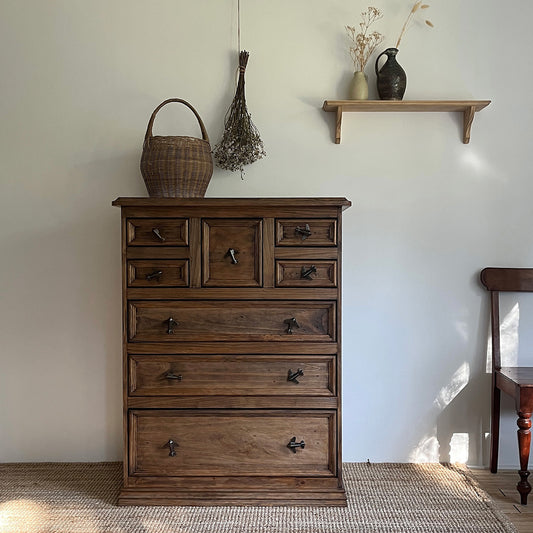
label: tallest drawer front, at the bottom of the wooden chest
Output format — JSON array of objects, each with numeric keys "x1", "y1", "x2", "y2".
[{"x1": 129, "y1": 410, "x2": 337, "y2": 477}]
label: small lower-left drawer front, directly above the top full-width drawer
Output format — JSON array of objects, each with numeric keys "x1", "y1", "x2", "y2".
[{"x1": 128, "y1": 259, "x2": 189, "y2": 287}]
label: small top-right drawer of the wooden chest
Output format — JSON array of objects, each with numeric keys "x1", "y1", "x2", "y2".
[{"x1": 276, "y1": 218, "x2": 337, "y2": 246}]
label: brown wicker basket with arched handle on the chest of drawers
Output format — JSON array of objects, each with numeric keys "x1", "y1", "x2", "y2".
[{"x1": 141, "y1": 98, "x2": 213, "y2": 198}]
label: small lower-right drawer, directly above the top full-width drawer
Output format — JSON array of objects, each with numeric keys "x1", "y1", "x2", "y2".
[{"x1": 276, "y1": 260, "x2": 337, "y2": 287}]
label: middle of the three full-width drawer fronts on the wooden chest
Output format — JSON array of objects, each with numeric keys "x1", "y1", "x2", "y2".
[{"x1": 129, "y1": 355, "x2": 335, "y2": 396}]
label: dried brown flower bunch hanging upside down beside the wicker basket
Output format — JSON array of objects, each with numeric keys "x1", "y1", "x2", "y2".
[{"x1": 213, "y1": 50, "x2": 266, "y2": 178}]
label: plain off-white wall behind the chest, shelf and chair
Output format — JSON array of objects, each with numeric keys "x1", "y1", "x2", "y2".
[{"x1": 0, "y1": 0, "x2": 533, "y2": 465}]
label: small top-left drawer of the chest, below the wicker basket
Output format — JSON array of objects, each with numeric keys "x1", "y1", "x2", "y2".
[{"x1": 126, "y1": 218, "x2": 189, "y2": 246}]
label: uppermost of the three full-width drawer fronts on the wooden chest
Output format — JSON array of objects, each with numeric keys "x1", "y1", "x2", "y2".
[{"x1": 128, "y1": 300, "x2": 336, "y2": 342}]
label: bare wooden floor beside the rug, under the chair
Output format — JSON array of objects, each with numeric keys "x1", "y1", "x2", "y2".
[{"x1": 470, "y1": 468, "x2": 533, "y2": 533}]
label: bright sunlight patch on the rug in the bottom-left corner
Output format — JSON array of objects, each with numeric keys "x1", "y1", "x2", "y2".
[{"x1": 0, "y1": 500, "x2": 49, "y2": 533}]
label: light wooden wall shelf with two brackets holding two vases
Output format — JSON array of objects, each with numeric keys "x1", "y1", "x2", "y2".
[{"x1": 322, "y1": 100, "x2": 490, "y2": 144}]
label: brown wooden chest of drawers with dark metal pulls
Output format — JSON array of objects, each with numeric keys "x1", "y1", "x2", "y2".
[{"x1": 113, "y1": 198, "x2": 351, "y2": 505}]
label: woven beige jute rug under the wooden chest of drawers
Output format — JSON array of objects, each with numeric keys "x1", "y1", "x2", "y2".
[{"x1": 0, "y1": 463, "x2": 516, "y2": 533}]
